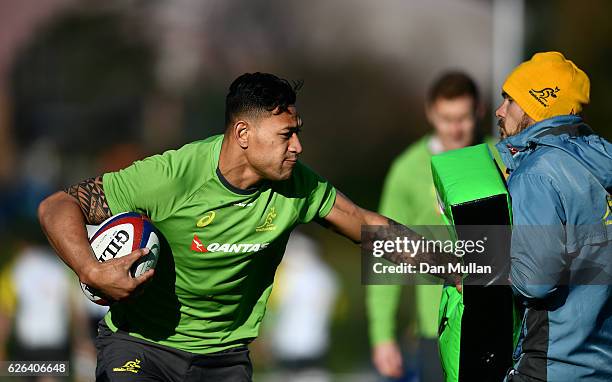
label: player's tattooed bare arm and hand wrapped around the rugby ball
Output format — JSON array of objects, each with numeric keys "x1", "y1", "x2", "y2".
[{"x1": 38, "y1": 176, "x2": 153, "y2": 300}]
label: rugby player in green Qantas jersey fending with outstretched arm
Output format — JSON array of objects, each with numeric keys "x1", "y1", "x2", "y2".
[{"x1": 39, "y1": 73, "x2": 450, "y2": 381}]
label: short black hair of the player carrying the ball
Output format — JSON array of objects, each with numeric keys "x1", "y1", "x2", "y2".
[{"x1": 225, "y1": 72, "x2": 303, "y2": 127}]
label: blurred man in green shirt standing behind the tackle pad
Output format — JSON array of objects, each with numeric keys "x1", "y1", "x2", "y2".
[{"x1": 366, "y1": 71, "x2": 495, "y2": 382}]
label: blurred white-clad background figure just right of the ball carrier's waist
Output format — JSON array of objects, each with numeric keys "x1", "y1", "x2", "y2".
[{"x1": 263, "y1": 231, "x2": 338, "y2": 382}]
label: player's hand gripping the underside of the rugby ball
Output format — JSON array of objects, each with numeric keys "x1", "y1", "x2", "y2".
[{"x1": 81, "y1": 248, "x2": 154, "y2": 301}]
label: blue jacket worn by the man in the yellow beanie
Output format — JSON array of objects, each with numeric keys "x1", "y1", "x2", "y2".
[{"x1": 497, "y1": 115, "x2": 612, "y2": 381}]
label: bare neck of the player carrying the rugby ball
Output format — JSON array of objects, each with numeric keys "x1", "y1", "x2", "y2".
[{"x1": 218, "y1": 139, "x2": 263, "y2": 190}]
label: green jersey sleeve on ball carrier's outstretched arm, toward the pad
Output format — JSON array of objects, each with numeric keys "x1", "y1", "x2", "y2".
[{"x1": 294, "y1": 162, "x2": 336, "y2": 223}]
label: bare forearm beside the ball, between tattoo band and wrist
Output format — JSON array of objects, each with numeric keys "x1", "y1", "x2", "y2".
[{"x1": 38, "y1": 191, "x2": 97, "y2": 283}]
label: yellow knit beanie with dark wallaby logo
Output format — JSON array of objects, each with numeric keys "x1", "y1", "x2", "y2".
[{"x1": 502, "y1": 52, "x2": 590, "y2": 122}]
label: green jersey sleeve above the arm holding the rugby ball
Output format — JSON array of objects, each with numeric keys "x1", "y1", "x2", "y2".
[{"x1": 102, "y1": 151, "x2": 191, "y2": 221}]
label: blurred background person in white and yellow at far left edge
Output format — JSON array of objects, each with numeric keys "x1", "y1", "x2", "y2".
[{"x1": 0, "y1": 219, "x2": 96, "y2": 381}]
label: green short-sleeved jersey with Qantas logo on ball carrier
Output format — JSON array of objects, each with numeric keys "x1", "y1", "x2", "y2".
[{"x1": 103, "y1": 135, "x2": 336, "y2": 354}]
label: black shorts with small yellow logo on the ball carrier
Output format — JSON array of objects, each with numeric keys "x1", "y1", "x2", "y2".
[{"x1": 96, "y1": 320, "x2": 253, "y2": 382}]
